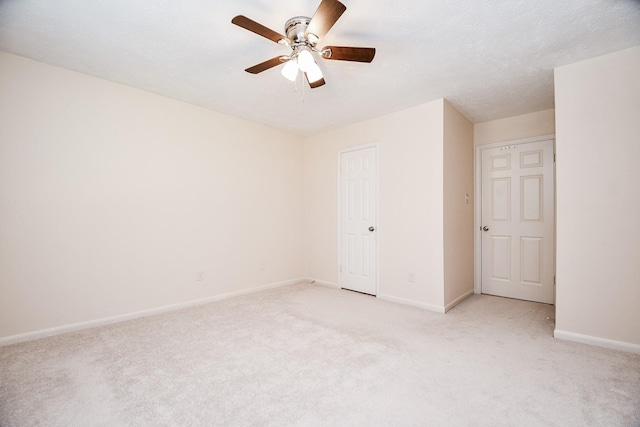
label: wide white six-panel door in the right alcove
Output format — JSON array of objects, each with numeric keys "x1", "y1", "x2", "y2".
[{"x1": 481, "y1": 140, "x2": 555, "y2": 304}]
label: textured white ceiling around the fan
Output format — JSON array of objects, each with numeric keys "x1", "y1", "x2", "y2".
[{"x1": 0, "y1": 0, "x2": 640, "y2": 135}]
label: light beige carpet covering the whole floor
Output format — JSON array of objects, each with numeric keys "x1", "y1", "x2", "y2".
[{"x1": 0, "y1": 284, "x2": 640, "y2": 427}]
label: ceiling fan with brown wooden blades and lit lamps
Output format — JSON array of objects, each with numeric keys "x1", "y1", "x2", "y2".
[{"x1": 231, "y1": 0, "x2": 376, "y2": 89}]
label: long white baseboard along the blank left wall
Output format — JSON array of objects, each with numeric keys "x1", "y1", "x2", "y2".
[{"x1": 0, "y1": 277, "x2": 305, "y2": 346}]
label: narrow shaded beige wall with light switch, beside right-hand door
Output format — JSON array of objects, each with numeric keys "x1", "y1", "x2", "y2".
[{"x1": 443, "y1": 102, "x2": 473, "y2": 309}]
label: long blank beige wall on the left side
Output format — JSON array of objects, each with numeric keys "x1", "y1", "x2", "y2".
[{"x1": 0, "y1": 53, "x2": 304, "y2": 338}]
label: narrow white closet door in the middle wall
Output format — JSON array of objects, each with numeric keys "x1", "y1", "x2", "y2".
[{"x1": 339, "y1": 147, "x2": 377, "y2": 295}]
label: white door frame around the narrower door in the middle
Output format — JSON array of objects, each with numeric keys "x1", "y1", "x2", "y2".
[{"x1": 336, "y1": 142, "x2": 380, "y2": 298}]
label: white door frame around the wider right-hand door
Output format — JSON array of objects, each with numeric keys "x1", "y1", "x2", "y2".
[{"x1": 473, "y1": 134, "x2": 556, "y2": 296}]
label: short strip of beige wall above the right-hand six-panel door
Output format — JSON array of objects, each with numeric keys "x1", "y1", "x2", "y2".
[{"x1": 473, "y1": 109, "x2": 555, "y2": 145}]
